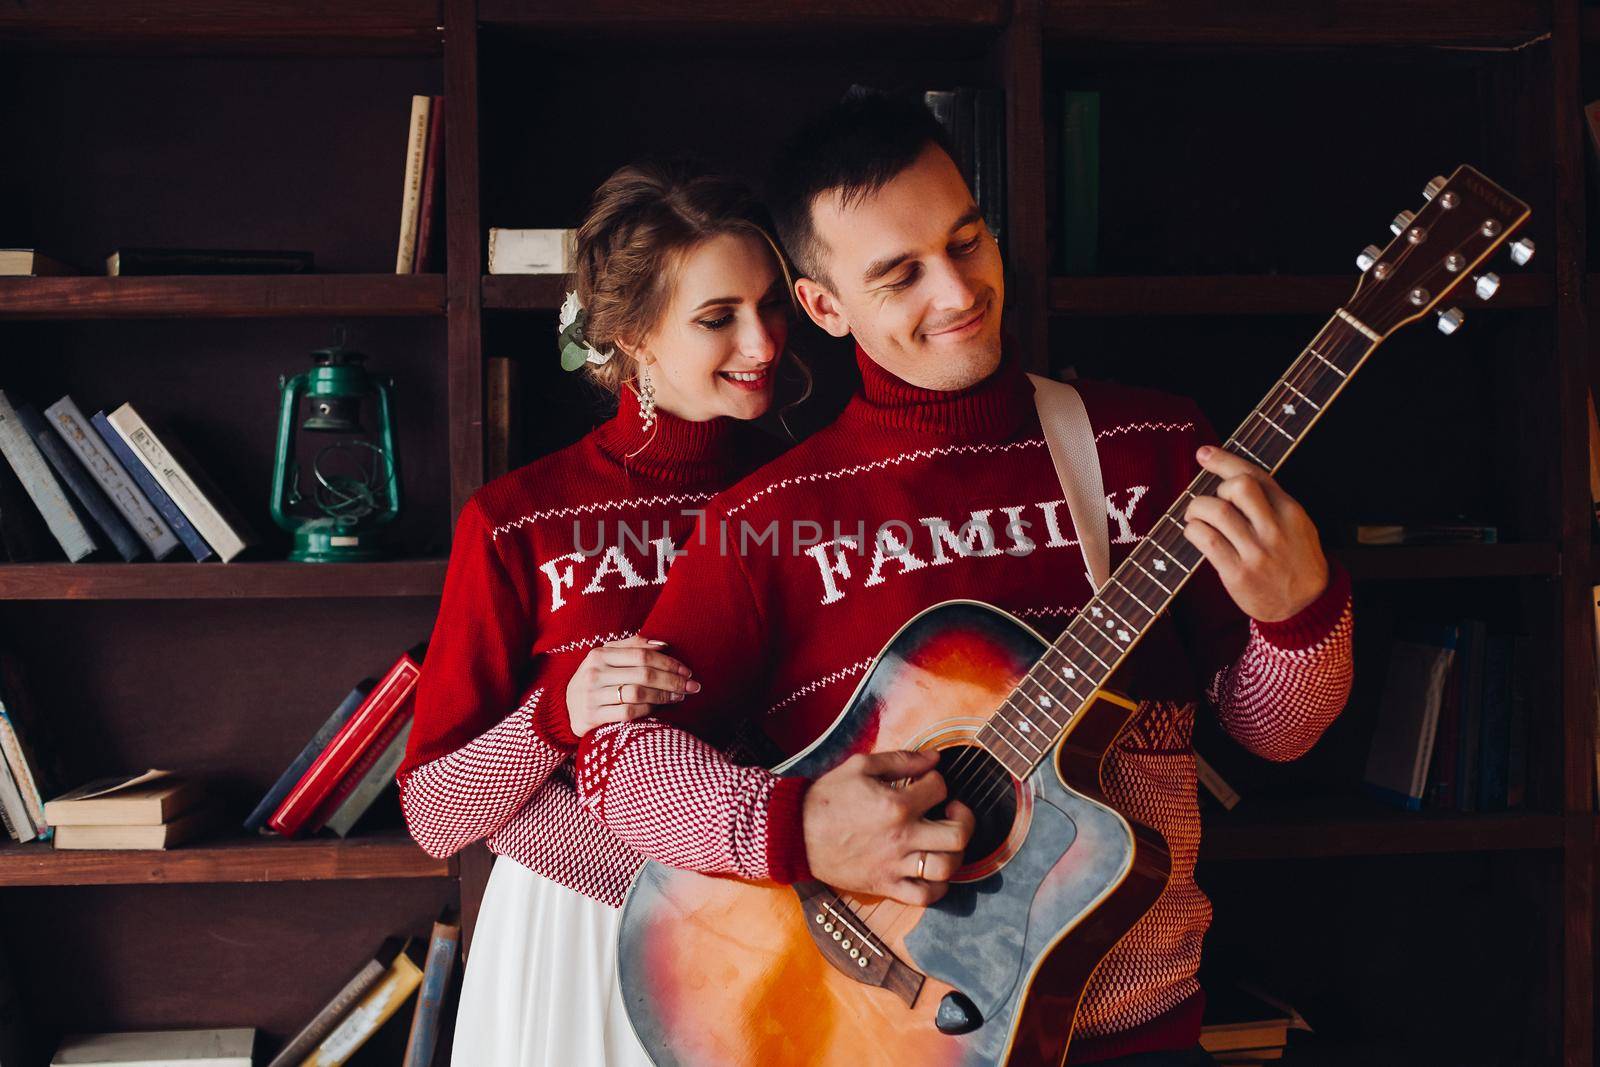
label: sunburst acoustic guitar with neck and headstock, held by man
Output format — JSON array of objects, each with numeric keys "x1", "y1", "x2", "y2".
[{"x1": 619, "y1": 166, "x2": 1533, "y2": 1067}]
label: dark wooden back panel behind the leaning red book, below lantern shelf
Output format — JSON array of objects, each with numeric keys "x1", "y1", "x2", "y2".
[{"x1": 0, "y1": 600, "x2": 435, "y2": 812}]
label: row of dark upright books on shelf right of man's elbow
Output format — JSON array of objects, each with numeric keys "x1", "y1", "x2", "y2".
[{"x1": 1366, "y1": 619, "x2": 1534, "y2": 811}]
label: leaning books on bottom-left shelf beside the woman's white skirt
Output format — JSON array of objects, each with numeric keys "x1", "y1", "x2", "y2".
[{"x1": 269, "y1": 913, "x2": 461, "y2": 1067}]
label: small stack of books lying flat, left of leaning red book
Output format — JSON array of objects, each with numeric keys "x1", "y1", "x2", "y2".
[{"x1": 45, "y1": 771, "x2": 213, "y2": 848}]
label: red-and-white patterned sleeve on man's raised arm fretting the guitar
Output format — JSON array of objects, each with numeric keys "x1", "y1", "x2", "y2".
[{"x1": 1206, "y1": 565, "x2": 1355, "y2": 761}]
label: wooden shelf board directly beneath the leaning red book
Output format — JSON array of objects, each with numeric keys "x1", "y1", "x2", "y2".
[{"x1": 0, "y1": 830, "x2": 454, "y2": 886}]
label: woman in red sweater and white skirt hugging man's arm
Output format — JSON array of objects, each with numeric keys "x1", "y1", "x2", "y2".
[{"x1": 398, "y1": 165, "x2": 806, "y2": 1067}]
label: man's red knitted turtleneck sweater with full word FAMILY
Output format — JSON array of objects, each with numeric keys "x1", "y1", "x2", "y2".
[{"x1": 546, "y1": 352, "x2": 1350, "y2": 1062}]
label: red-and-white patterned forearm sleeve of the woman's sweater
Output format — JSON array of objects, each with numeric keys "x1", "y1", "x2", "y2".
[{"x1": 400, "y1": 686, "x2": 571, "y2": 857}]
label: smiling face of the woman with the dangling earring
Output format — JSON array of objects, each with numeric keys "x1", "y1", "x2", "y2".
[{"x1": 638, "y1": 234, "x2": 790, "y2": 422}]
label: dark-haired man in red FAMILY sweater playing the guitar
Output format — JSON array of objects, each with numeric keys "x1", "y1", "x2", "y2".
[{"x1": 546, "y1": 96, "x2": 1350, "y2": 1062}]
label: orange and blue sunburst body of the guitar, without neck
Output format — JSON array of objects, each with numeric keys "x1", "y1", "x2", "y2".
[{"x1": 619, "y1": 601, "x2": 1168, "y2": 1067}]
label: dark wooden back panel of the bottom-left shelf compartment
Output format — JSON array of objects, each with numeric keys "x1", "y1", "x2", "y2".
[{"x1": 0, "y1": 878, "x2": 454, "y2": 1065}]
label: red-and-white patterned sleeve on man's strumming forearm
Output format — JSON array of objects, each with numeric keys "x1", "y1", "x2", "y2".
[{"x1": 576, "y1": 718, "x2": 811, "y2": 883}]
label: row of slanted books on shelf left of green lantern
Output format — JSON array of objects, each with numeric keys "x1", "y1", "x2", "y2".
[{"x1": 0, "y1": 392, "x2": 258, "y2": 563}]
